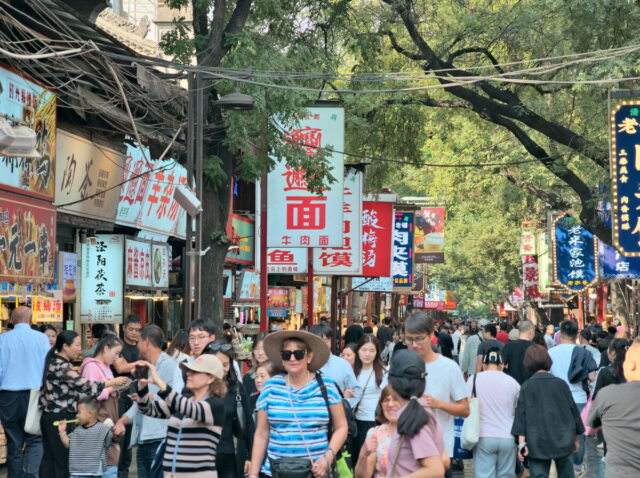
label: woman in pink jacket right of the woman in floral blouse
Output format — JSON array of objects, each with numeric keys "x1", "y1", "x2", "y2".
[{"x1": 78, "y1": 334, "x2": 124, "y2": 478}]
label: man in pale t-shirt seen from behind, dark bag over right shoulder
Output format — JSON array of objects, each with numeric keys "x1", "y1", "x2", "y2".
[{"x1": 549, "y1": 320, "x2": 596, "y2": 478}]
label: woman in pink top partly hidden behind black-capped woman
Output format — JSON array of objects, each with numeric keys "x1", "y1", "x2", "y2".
[{"x1": 354, "y1": 385, "x2": 399, "y2": 478}]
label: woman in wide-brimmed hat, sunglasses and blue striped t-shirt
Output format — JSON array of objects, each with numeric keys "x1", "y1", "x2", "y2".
[{"x1": 249, "y1": 330, "x2": 348, "y2": 478}]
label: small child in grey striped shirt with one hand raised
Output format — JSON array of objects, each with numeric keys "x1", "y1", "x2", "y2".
[{"x1": 58, "y1": 397, "x2": 112, "y2": 478}]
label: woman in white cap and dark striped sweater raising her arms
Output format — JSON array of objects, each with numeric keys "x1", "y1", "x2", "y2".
[{"x1": 133, "y1": 354, "x2": 226, "y2": 478}]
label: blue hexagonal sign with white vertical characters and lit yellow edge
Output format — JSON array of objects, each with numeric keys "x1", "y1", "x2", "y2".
[{"x1": 552, "y1": 216, "x2": 598, "y2": 292}]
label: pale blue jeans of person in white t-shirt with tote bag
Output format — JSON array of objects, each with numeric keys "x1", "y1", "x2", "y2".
[{"x1": 473, "y1": 437, "x2": 516, "y2": 478}]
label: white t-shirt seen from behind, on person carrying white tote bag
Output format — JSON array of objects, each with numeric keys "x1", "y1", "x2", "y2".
[{"x1": 467, "y1": 370, "x2": 520, "y2": 438}]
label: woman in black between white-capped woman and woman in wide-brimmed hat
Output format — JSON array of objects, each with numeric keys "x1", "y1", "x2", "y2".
[{"x1": 205, "y1": 344, "x2": 254, "y2": 478}]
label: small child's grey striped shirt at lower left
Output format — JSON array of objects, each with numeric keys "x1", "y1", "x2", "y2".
[{"x1": 69, "y1": 422, "x2": 112, "y2": 476}]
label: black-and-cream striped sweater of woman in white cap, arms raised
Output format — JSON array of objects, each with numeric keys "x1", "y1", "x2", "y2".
[{"x1": 138, "y1": 385, "x2": 224, "y2": 477}]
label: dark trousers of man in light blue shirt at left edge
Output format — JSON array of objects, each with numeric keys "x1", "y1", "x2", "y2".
[{"x1": 0, "y1": 390, "x2": 42, "y2": 478}]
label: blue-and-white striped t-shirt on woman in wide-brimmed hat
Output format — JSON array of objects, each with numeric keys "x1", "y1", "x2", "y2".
[{"x1": 257, "y1": 375, "x2": 342, "y2": 475}]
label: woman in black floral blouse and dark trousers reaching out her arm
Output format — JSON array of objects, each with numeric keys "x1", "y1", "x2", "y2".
[{"x1": 40, "y1": 330, "x2": 128, "y2": 478}]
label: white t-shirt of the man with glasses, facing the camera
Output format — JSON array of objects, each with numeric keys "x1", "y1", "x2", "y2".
[{"x1": 424, "y1": 355, "x2": 469, "y2": 457}]
